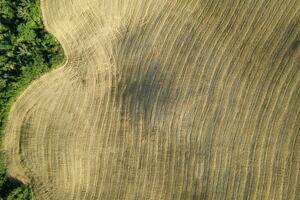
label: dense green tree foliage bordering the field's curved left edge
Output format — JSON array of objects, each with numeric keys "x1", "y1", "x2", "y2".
[{"x1": 0, "y1": 0, "x2": 63, "y2": 200}]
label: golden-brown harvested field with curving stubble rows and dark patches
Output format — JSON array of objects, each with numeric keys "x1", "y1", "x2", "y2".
[{"x1": 4, "y1": 0, "x2": 300, "y2": 200}]
